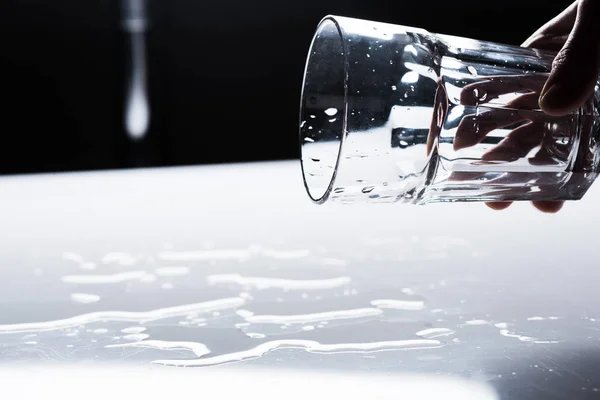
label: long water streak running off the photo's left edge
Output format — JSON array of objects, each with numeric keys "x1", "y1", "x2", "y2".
[{"x1": 0, "y1": 297, "x2": 246, "y2": 334}]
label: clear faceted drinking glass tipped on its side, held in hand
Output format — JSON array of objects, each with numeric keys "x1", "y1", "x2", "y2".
[{"x1": 300, "y1": 16, "x2": 600, "y2": 204}]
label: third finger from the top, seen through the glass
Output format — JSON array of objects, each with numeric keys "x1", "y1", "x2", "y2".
[{"x1": 481, "y1": 122, "x2": 544, "y2": 162}]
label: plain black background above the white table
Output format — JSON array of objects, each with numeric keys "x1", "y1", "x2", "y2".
[{"x1": 0, "y1": 0, "x2": 569, "y2": 174}]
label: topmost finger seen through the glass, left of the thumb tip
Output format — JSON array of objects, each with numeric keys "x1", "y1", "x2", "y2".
[{"x1": 460, "y1": 74, "x2": 547, "y2": 106}]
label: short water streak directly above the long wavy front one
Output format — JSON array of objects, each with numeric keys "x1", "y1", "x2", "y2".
[{"x1": 246, "y1": 308, "x2": 383, "y2": 325}]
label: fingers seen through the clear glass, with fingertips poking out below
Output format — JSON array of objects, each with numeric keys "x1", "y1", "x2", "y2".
[{"x1": 458, "y1": 74, "x2": 573, "y2": 212}]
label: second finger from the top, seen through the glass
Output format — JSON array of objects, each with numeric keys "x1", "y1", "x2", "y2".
[{"x1": 453, "y1": 110, "x2": 523, "y2": 151}]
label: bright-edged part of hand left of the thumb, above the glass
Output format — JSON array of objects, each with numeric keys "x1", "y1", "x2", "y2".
[{"x1": 521, "y1": 1, "x2": 578, "y2": 50}]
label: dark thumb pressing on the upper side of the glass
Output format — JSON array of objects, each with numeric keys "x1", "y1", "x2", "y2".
[{"x1": 539, "y1": 0, "x2": 600, "y2": 116}]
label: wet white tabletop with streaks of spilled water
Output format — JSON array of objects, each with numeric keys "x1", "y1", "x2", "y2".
[{"x1": 0, "y1": 162, "x2": 600, "y2": 399}]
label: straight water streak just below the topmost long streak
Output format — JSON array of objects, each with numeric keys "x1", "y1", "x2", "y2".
[{"x1": 206, "y1": 274, "x2": 351, "y2": 290}]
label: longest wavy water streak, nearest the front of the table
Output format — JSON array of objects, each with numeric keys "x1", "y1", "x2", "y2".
[{"x1": 151, "y1": 339, "x2": 443, "y2": 367}]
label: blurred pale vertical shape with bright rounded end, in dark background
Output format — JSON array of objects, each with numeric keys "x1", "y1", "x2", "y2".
[{"x1": 121, "y1": 0, "x2": 150, "y2": 141}]
